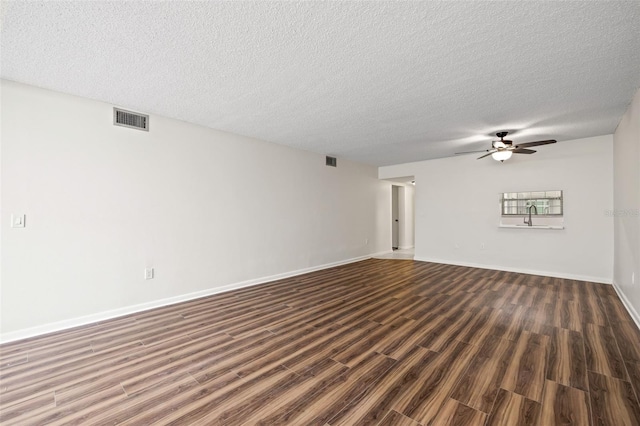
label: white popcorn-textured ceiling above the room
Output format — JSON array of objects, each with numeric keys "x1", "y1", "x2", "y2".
[{"x1": 0, "y1": 1, "x2": 640, "y2": 165}]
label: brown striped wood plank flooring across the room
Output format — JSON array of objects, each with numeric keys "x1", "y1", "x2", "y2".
[{"x1": 0, "y1": 259, "x2": 640, "y2": 426}]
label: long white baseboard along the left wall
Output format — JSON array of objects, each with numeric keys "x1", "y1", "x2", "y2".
[{"x1": 0, "y1": 252, "x2": 376, "y2": 343}]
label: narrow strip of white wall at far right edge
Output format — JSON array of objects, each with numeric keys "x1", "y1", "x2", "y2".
[{"x1": 613, "y1": 91, "x2": 640, "y2": 326}]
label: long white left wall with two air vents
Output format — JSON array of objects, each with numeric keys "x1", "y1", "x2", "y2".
[{"x1": 0, "y1": 81, "x2": 391, "y2": 341}]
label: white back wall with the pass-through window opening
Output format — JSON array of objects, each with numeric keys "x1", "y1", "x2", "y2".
[{"x1": 378, "y1": 135, "x2": 613, "y2": 283}]
